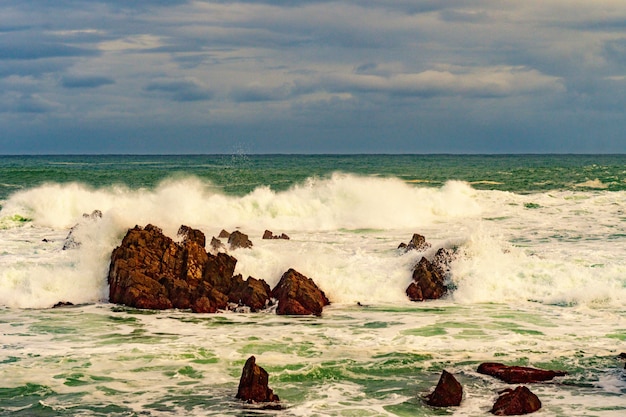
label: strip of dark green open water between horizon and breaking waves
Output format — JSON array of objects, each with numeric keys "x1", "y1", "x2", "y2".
[{"x1": 0, "y1": 154, "x2": 626, "y2": 199}]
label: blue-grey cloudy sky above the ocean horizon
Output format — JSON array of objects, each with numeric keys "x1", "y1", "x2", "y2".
[{"x1": 0, "y1": 0, "x2": 626, "y2": 154}]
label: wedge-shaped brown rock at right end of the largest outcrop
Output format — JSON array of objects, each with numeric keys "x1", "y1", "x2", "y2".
[{"x1": 272, "y1": 269, "x2": 330, "y2": 316}]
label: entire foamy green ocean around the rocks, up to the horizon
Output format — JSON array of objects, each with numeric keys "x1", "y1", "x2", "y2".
[{"x1": 0, "y1": 153, "x2": 626, "y2": 417}]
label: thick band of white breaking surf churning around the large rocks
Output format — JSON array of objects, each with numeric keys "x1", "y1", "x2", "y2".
[{"x1": 0, "y1": 174, "x2": 626, "y2": 307}]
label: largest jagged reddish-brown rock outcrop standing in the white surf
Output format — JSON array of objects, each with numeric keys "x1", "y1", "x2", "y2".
[{"x1": 108, "y1": 225, "x2": 270, "y2": 313}]
